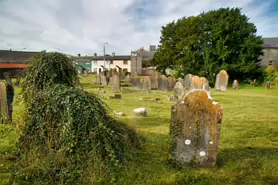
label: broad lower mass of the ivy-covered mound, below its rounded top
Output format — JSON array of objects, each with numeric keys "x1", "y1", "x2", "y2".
[{"x1": 14, "y1": 85, "x2": 140, "y2": 184}]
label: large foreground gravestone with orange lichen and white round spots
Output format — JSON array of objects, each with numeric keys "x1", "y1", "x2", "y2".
[{"x1": 170, "y1": 90, "x2": 223, "y2": 167}]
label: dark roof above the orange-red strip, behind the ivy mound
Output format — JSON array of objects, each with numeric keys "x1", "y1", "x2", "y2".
[{"x1": 0, "y1": 50, "x2": 40, "y2": 64}]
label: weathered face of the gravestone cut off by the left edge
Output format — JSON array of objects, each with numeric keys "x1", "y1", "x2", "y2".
[{"x1": 0, "y1": 82, "x2": 8, "y2": 119}]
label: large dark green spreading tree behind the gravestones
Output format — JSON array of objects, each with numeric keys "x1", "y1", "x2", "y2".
[{"x1": 152, "y1": 8, "x2": 263, "y2": 85}]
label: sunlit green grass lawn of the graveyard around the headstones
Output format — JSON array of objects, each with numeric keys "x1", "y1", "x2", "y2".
[{"x1": 0, "y1": 76, "x2": 278, "y2": 185}]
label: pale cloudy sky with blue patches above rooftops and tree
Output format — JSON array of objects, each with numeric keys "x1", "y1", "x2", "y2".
[{"x1": 0, "y1": 0, "x2": 278, "y2": 56}]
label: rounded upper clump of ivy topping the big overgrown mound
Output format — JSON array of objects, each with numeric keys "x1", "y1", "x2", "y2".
[{"x1": 23, "y1": 52, "x2": 77, "y2": 100}]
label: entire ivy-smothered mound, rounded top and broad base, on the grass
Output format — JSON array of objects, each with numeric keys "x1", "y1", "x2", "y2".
[{"x1": 13, "y1": 53, "x2": 140, "y2": 184}]
